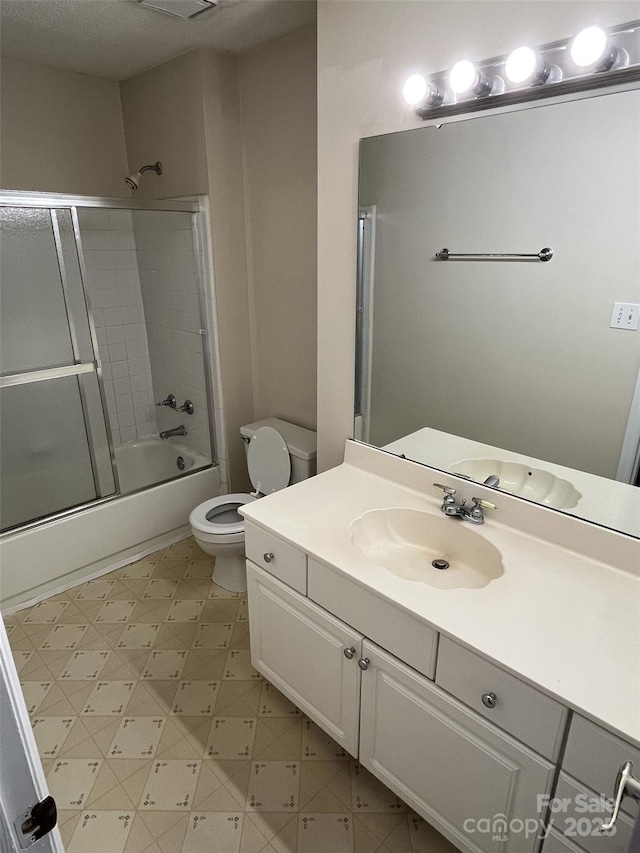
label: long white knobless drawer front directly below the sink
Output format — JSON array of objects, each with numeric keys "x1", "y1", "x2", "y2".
[{"x1": 307, "y1": 557, "x2": 438, "y2": 681}]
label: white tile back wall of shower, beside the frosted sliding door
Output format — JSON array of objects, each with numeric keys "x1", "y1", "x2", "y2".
[{"x1": 78, "y1": 208, "x2": 157, "y2": 445}]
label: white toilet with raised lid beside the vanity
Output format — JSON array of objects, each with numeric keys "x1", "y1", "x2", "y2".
[{"x1": 189, "y1": 418, "x2": 316, "y2": 592}]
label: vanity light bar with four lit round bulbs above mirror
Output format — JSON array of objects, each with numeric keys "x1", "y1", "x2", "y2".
[{"x1": 403, "y1": 20, "x2": 640, "y2": 119}]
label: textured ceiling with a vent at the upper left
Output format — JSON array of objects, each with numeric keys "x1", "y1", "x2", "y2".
[{"x1": 0, "y1": 0, "x2": 316, "y2": 80}]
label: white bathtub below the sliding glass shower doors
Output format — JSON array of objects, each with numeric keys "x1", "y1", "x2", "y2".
[{"x1": 0, "y1": 438, "x2": 221, "y2": 614}]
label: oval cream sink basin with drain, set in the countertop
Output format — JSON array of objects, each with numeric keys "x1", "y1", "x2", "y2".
[{"x1": 351, "y1": 507, "x2": 504, "y2": 589}]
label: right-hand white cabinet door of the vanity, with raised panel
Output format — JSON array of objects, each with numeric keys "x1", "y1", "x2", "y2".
[{"x1": 360, "y1": 641, "x2": 554, "y2": 853}]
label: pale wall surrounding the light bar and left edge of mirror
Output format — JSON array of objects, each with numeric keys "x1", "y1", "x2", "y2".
[{"x1": 318, "y1": 0, "x2": 640, "y2": 470}]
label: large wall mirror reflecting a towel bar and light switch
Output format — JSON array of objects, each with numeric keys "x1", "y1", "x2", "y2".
[{"x1": 355, "y1": 89, "x2": 640, "y2": 537}]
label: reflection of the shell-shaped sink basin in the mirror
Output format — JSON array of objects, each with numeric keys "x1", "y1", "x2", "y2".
[{"x1": 450, "y1": 459, "x2": 582, "y2": 509}]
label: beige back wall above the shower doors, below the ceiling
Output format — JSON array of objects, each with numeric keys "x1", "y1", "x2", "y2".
[{"x1": 0, "y1": 59, "x2": 129, "y2": 196}]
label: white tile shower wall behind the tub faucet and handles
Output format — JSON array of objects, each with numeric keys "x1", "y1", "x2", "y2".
[{"x1": 133, "y1": 211, "x2": 211, "y2": 459}]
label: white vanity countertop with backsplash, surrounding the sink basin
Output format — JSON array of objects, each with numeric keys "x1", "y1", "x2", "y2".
[{"x1": 240, "y1": 442, "x2": 640, "y2": 745}]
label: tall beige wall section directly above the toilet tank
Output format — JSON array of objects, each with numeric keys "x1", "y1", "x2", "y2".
[{"x1": 239, "y1": 25, "x2": 317, "y2": 430}]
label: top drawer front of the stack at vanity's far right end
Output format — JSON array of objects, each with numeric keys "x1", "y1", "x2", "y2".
[{"x1": 562, "y1": 714, "x2": 640, "y2": 815}]
